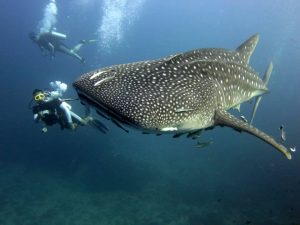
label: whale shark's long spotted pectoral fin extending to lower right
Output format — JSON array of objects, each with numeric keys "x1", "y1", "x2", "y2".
[{"x1": 214, "y1": 110, "x2": 292, "y2": 159}]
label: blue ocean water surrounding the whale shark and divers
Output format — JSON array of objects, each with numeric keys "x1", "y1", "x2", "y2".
[{"x1": 0, "y1": 0, "x2": 300, "y2": 225}]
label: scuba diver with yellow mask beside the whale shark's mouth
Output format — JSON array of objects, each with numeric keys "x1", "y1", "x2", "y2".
[{"x1": 31, "y1": 81, "x2": 108, "y2": 133}]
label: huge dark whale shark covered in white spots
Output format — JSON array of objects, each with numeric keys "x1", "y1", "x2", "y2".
[{"x1": 73, "y1": 34, "x2": 292, "y2": 159}]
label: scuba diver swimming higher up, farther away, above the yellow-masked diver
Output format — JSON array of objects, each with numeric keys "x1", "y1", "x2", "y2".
[{"x1": 29, "y1": 29, "x2": 96, "y2": 63}]
